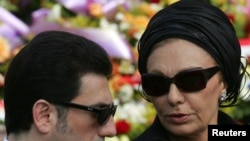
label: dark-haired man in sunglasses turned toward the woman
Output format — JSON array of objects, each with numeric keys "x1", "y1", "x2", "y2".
[{"x1": 4, "y1": 31, "x2": 116, "y2": 141}]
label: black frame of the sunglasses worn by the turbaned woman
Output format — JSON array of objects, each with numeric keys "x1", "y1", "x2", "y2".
[{"x1": 141, "y1": 66, "x2": 220, "y2": 101}]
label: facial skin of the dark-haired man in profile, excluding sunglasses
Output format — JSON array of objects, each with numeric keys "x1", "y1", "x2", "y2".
[{"x1": 54, "y1": 73, "x2": 116, "y2": 141}]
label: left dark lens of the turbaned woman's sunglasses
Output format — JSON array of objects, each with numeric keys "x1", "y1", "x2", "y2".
[{"x1": 142, "y1": 74, "x2": 170, "y2": 96}]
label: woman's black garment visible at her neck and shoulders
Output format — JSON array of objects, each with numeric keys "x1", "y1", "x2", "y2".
[{"x1": 134, "y1": 111, "x2": 238, "y2": 141}]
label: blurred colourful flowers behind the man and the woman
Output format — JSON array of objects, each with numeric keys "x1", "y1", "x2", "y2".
[{"x1": 0, "y1": 0, "x2": 250, "y2": 141}]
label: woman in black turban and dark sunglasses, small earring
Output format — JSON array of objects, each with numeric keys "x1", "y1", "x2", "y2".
[{"x1": 135, "y1": 0, "x2": 247, "y2": 141}]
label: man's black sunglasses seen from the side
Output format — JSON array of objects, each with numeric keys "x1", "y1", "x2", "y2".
[{"x1": 56, "y1": 102, "x2": 117, "y2": 125}]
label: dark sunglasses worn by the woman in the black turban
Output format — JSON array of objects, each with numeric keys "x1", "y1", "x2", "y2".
[{"x1": 142, "y1": 66, "x2": 220, "y2": 96}]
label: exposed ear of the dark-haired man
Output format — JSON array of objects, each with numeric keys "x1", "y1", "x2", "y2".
[{"x1": 32, "y1": 99, "x2": 57, "y2": 134}]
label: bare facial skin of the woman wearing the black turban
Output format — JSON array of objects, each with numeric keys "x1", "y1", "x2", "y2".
[{"x1": 147, "y1": 39, "x2": 226, "y2": 136}]
